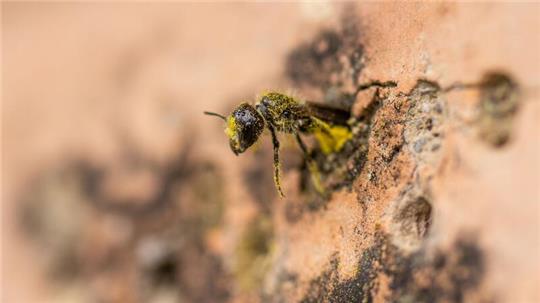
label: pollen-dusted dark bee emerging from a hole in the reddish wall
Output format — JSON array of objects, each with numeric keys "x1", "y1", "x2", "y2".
[{"x1": 204, "y1": 92, "x2": 352, "y2": 197}]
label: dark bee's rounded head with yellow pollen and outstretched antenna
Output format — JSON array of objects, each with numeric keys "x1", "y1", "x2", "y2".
[{"x1": 205, "y1": 103, "x2": 265, "y2": 155}]
